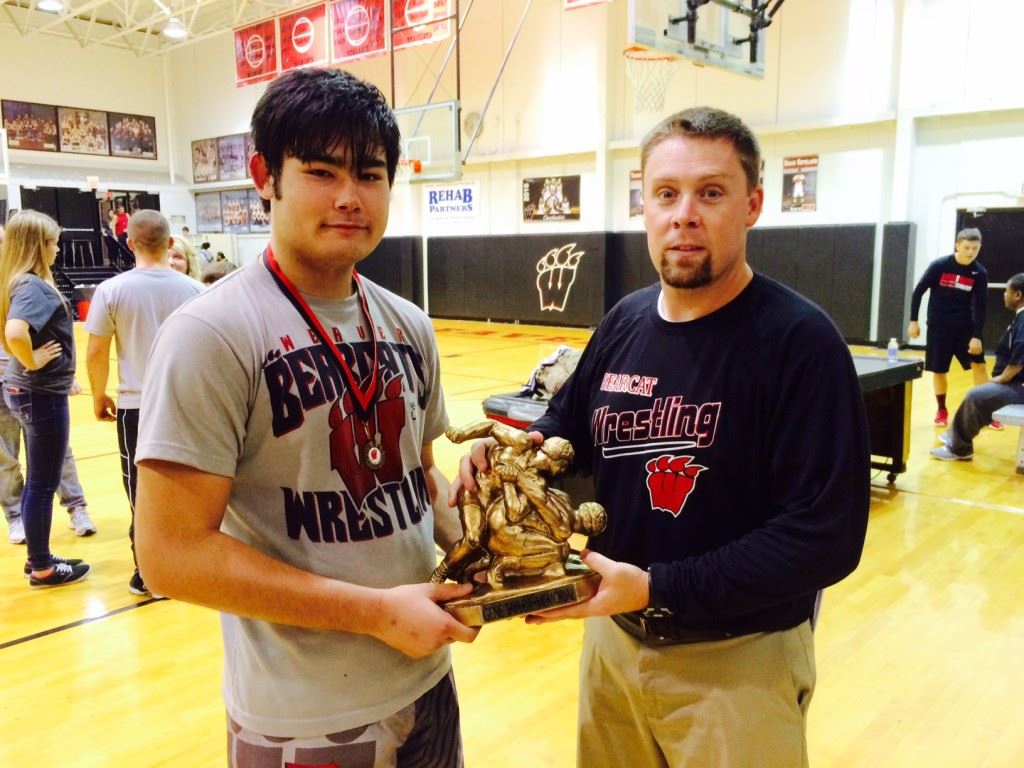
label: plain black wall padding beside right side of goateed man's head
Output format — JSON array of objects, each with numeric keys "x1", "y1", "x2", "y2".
[{"x1": 746, "y1": 224, "x2": 874, "y2": 341}]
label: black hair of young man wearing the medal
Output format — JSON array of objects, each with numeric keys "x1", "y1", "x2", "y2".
[{"x1": 252, "y1": 67, "x2": 401, "y2": 211}]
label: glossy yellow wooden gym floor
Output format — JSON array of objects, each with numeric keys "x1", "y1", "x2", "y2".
[{"x1": 0, "y1": 321, "x2": 1024, "y2": 768}]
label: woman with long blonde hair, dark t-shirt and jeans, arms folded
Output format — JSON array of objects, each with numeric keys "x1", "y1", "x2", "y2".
[{"x1": 0, "y1": 211, "x2": 89, "y2": 588}]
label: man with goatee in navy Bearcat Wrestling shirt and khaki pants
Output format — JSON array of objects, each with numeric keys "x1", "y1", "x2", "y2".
[{"x1": 455, "y1": 108, "x2": 869, "y2": 768}]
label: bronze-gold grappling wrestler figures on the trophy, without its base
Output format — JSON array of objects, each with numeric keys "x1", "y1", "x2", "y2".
[{"x1": 430, "y1": 420, "x2": 607, "y2": 590}]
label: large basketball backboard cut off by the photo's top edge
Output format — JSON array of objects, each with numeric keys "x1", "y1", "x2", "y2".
[{"x1": 627, "y1": 0, "x2": 765, "y2": 77}]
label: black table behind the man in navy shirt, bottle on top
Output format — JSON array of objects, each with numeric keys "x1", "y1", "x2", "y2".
[{"x1": 483, "y1": 354, "x2": 925, "y2": 487}]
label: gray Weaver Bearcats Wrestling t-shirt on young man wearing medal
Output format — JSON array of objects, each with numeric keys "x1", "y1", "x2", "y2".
[{"x1": 136, "y1": 260, "x2": 451, "y2": 736}]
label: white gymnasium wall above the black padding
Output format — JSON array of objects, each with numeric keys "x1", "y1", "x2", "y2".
[{"x1": 159, "y1": 0, "x2": 1024, "y2": 282}]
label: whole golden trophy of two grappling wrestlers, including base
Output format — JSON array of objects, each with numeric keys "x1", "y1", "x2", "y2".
[{"x1": 430, "y1": 420, "x2": 607, "y2": 627}]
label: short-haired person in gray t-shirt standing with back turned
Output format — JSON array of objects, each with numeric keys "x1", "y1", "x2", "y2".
[{"x1": 85, "y1": 210, "x2": 203, "y2": 595}]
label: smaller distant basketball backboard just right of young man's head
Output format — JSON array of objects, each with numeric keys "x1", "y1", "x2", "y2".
[{"x1": 394, "y1": 101, "x2": 462, "y2": 181}]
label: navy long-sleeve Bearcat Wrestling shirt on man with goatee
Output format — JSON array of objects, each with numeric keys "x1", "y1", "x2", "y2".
[{"x1": 534, "y1": 275, "x2": 869, "y2": 634}]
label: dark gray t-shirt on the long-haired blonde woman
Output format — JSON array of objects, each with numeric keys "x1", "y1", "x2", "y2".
[{"x1": 3, "y1": 274, "x2": 75, "y2": 394}]
